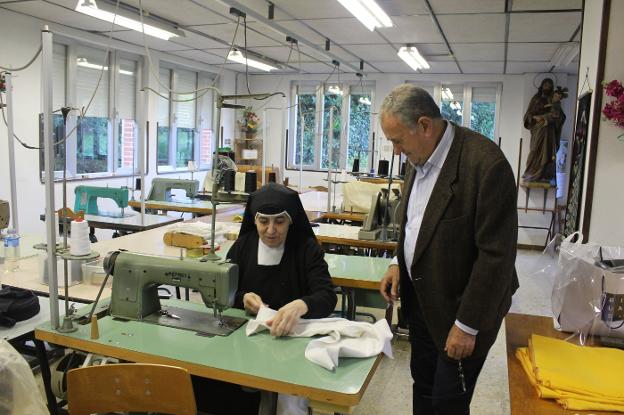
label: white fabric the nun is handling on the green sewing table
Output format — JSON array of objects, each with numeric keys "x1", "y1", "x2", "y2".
[{"x1": 245, "y1": 307, "x2": 392, "y2": 370}]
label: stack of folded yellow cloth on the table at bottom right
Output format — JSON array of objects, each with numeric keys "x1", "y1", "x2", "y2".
[{"x1": 516, "y1": 334, "x2": 624, "y2": 412}]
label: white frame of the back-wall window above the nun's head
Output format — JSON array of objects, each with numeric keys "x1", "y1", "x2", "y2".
[{"x1": 285, "y1": 81, "x2": 375, "y2": 172}]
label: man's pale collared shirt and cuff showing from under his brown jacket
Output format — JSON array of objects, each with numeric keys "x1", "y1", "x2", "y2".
[{"x1": 391, "y1": 122, "x2": 479, "y2": 336}]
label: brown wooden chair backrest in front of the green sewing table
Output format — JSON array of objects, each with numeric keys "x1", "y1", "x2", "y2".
[{"x1": 67, "y1": 363, "x2": 197, "y2": 415}]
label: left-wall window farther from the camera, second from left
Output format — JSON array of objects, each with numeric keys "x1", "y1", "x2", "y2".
[{"x1": 157, "y1": 68, "x2": 213, "y2": 173}]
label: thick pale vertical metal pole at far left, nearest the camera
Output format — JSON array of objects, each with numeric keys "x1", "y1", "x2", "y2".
[{"x1": 41, "y1": 25, "x2": 59, "y2": 330}]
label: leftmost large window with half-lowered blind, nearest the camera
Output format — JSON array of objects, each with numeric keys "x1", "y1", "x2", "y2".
[{"x1": 40, "y1": 41, "x2": 141, "y2": 179}]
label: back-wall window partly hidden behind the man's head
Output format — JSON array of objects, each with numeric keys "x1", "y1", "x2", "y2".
[{"x1": 410, "y1": 84, "x2": 502, "y2": 140}]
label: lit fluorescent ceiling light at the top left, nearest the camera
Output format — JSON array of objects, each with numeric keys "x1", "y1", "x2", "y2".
[{"x1": 75, "y1": 0, "x2": 183, "y2": 40}]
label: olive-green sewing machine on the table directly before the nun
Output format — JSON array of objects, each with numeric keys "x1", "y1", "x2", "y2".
[{"x1": 104, "y1": 251, "x2": 246, "y2": 336}]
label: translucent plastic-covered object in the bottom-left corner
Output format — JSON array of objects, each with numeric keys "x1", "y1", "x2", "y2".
[{"x1": 0, "y1": 339, "x2": 49, "y2": 415}]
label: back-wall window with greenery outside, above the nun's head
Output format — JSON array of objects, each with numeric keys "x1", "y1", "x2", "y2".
[{"x1": 287, "y1": 83, "x2": 373, "y2": 171}]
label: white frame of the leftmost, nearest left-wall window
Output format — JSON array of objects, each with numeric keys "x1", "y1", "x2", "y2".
[{"x1": 39, "y1": 37, "x2": 149, "y2": 183}]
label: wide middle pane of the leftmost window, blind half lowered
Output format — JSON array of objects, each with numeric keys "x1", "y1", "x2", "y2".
[{"x1": 76, "y1": 46, "x2": 109, "y2": 174}]
